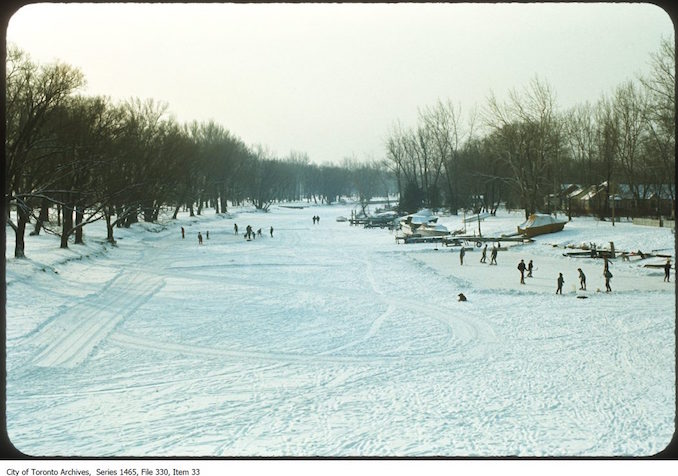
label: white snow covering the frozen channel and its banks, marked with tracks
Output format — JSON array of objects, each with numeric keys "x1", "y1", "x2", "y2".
[{"x1": 6, "y1": 206, "x2": 675, "y2": 457}]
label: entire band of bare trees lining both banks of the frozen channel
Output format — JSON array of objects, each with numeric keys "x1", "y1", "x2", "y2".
[{"x1": 5, "y1": 40, "x2": 675, "y2": 257}]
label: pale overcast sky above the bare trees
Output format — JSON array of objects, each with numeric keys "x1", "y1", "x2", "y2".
[{"x1": 7, "y1": 3, "x2": 674, "y2": 163}]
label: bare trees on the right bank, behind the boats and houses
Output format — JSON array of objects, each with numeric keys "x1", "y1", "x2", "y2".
[{"x1": 386, "y1": 40, "x2": 675, "y2": 221}]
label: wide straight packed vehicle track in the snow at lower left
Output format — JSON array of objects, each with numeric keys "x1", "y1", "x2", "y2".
[{"x1": 30, "y1": 274, "x2": 164, "y2": 368}]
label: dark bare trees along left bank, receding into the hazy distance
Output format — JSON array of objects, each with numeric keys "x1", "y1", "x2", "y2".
[{"x1": 5, "y1": 46, "x2": 395, "y2": 257}]
